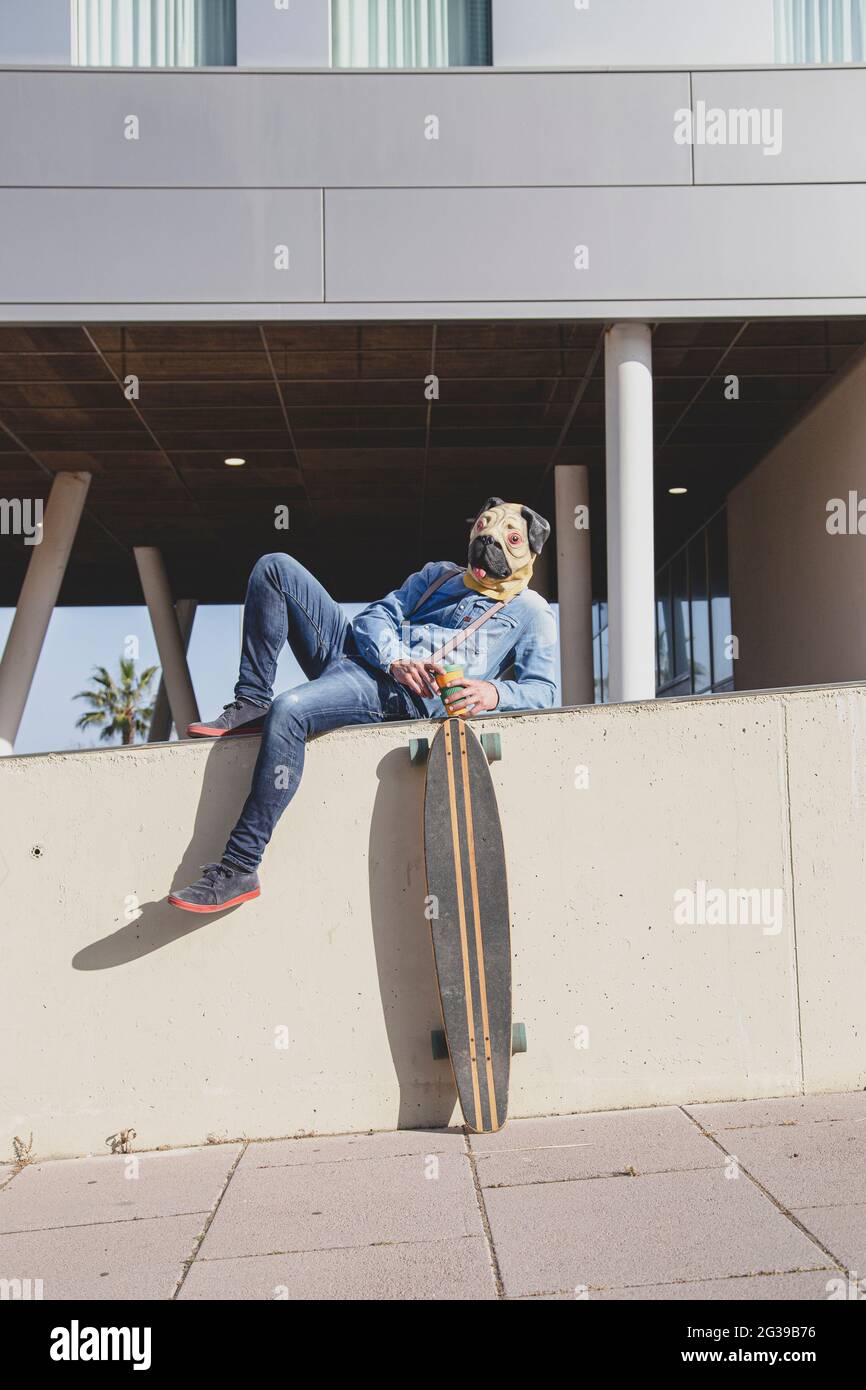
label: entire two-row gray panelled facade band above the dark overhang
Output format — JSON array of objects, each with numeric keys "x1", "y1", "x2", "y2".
[{"x1": 0, "y1": 65, "x2": 866, "y2": 322}]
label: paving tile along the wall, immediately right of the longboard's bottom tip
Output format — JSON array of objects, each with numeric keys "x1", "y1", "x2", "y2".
[{"x1": 470, "y1": 1106, "x2": 724, "y2": 1187}]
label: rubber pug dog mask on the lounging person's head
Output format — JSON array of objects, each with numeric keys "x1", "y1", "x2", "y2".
[{"x1": 463, "y1": 498, "x2": 550, "y2": 603}]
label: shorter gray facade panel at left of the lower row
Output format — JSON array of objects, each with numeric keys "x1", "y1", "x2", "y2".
[{"x1": 0, "y1": 189, "x2": 322, "y2": 304}]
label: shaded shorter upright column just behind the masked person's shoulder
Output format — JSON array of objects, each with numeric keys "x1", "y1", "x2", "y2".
[{"x1": 553, "y1": 463, "x2": 595, "y2": 705}]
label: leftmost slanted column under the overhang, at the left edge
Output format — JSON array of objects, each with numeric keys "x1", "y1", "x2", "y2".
[{"x1": 0, "y1": 473, "x2": 90, "y2": 755}]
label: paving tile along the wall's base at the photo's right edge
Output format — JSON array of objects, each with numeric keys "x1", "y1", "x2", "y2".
[{"x1": 708, "y1": 1120, "x2": 866, "y2": 1209}]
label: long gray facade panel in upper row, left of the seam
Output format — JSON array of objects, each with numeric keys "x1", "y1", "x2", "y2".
[{"x1": 0, "y1": 71, "x2": 691, "y2": 188}]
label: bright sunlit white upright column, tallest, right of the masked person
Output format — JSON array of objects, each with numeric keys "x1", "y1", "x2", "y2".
[{"x1": 605, "y1": 324, "x2": 656, "y2": 701}]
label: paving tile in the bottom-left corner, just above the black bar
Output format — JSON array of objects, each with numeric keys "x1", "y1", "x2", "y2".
[{"x1": 0, "y1": 1217, "x2": 204, "y2": 1300}]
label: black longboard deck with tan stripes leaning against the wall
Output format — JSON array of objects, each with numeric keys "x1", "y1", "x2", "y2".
[{"x1": 424, "y1": 719, "x2": 512, "y2": 1133}]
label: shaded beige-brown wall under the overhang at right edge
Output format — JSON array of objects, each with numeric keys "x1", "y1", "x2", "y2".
[{"x1": 727, "y1": 357, "x2": 866, "y2": 689}]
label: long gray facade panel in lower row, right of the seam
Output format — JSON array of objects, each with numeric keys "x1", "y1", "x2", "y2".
[{"x1": 325, "y1": 185, "x2": 866, "y2": 303}]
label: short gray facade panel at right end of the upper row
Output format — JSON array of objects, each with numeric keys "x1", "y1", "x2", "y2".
[{"x1": 692, "y1": 67, "x2": 866, "y2": 184}]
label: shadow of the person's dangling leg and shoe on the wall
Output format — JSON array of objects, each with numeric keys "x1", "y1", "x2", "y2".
[{"x1": 72, "y1": 735, "x2": 259, "y2": 970}]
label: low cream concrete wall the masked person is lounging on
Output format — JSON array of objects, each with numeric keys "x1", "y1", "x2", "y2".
[{"x1": 0, "y1": 687, "x2": 866, "y2": 1159}]
